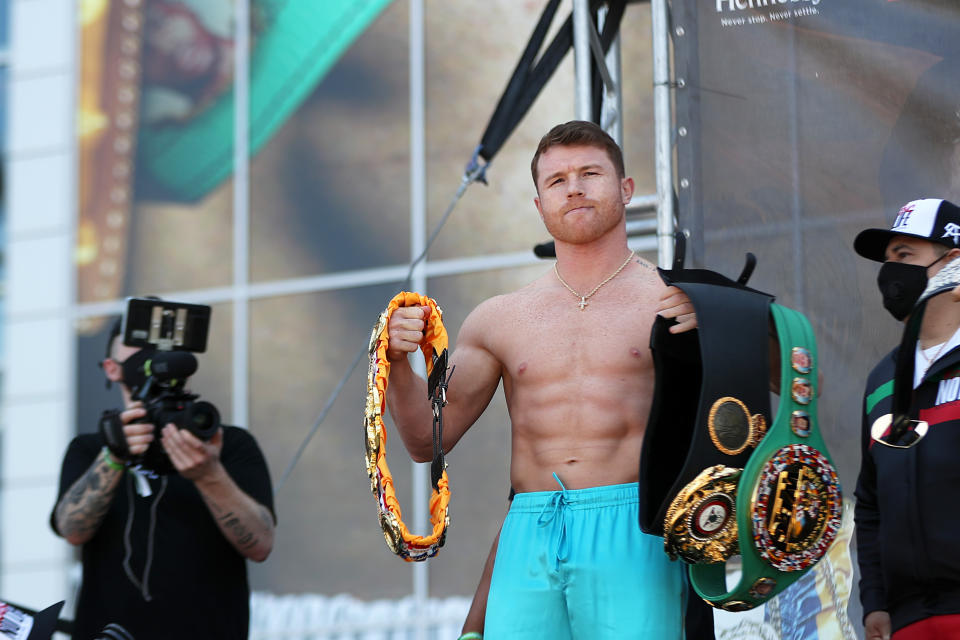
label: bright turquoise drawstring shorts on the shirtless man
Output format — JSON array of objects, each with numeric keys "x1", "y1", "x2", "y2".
[{"x1": 483, "y1": 480, "x2": 687, "y2": 640}]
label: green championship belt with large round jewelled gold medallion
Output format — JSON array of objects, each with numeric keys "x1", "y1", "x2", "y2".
[{"x1": 690, "y1": 304, "x2": 843, "y2": 611}]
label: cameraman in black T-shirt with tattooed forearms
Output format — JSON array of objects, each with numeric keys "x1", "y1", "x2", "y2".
[{"x1": 50, "y1": 321, "x2": 276, "y2": 640}]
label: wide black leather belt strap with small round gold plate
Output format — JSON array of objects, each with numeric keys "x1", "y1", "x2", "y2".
[{"x1": 639, "y1": 264, "x2": 773, "y2": 535}]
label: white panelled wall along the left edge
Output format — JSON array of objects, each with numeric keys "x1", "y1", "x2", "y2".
[{"x1": 0, "y1": 0, "x2": 77, "y2": 609}]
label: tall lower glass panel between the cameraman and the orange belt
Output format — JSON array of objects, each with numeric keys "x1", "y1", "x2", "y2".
[{"x1": 250, "y1": 285, "x2": 413, "y2": 599}]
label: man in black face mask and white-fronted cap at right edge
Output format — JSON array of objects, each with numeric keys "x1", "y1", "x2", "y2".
[{"x1": 854, "y1": 199, "x2": 960, "y2": 640}]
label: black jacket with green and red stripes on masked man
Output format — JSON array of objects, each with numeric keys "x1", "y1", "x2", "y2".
[{"x1": 855, "y1": 348, "x2": 960, "y2": 631}]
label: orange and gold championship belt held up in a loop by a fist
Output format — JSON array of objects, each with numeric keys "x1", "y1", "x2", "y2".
[{"x1": 363, "y1": 292, "x2": 450, "y2": 562}]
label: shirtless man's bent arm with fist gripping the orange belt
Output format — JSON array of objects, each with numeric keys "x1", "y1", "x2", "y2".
[{"x1": 387, "y1": 303, "x2": 501, "y2": 462}]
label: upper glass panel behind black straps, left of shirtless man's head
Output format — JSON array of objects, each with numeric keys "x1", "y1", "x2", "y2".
[{"x1": 426, "y1": 0, "x2": 574, "y2": 260}]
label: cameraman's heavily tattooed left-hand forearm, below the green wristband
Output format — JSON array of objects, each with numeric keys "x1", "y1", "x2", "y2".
[{"x1": 54, "y1": 452, "x2": 123, "y2": 545}]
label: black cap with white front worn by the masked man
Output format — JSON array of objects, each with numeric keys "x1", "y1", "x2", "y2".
[{"x1": 853, "y1": 198, "x2": 960, "y2": 262}]
